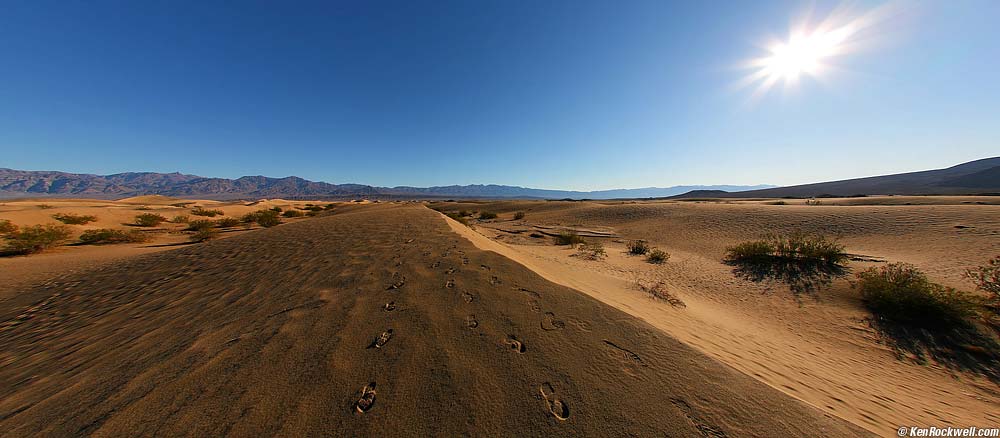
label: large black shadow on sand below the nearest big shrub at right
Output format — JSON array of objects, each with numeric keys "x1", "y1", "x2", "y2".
[{"x1": 868, "y1": 317, "x2": 1000, "y2": 384}]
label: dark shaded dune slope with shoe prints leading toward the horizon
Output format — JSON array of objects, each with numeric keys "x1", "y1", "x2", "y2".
[{"x1": 0, "y1": 205, "x2": 865, "y2": 436}]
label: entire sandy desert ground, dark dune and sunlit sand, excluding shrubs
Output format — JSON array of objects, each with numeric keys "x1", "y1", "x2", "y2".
[{"x1": 0, "y1": 197, "x2": 1000, "y2": 436}]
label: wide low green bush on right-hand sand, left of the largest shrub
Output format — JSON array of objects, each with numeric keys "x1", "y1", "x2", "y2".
[{"x1": 726, "y1": 233, "x2": 847, "y2": 264}]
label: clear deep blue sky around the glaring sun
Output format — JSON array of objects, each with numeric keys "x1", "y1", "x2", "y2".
[{"x1": 0, "y1": 0, "x2": 1000, "y2": 189}]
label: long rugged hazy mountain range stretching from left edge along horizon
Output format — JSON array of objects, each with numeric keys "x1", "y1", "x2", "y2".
[{"x1": 0, "y1": 169, "x2": 774, "y2": 199}]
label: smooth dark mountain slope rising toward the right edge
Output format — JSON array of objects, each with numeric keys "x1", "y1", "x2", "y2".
[{"x1": 676, "y1": 157, "x2": 1000, "y2": 198}]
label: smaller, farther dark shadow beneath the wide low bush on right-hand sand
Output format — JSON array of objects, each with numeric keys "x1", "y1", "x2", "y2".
[{"x1": 725, "y1": 257, "x2": 847, "y2": 297}]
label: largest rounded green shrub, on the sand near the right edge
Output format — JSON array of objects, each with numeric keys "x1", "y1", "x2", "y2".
[{"x1": 855, "y1": 263, "x2": 978, "y2": 329}]
